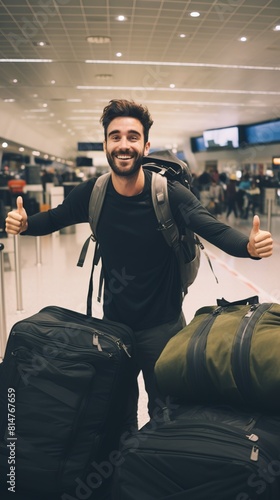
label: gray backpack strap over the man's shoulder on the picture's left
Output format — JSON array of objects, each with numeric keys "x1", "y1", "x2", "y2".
[{"x1": 88, "y1": 172, "x2": 111, "y2": 241}]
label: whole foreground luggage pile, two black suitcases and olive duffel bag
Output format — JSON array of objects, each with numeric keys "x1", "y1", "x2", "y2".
[{"x1": 0, "y1": 297, "x2": 280, "y2": 500}]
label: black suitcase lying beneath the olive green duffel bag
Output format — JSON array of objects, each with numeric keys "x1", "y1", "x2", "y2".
[{"x1": 113, "y1": 406, "x2": 280, "y2": 500}]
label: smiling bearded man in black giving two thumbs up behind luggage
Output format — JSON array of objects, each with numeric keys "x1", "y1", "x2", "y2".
[{"x1": 6, "y1": 100, "x2": 273, "y2": 424}]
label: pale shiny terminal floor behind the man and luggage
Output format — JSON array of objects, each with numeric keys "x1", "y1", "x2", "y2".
[{"x1": 0, "y1": 210, "x2": 280, "y2": 425}]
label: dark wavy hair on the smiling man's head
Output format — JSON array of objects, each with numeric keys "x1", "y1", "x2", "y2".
[{"x1": 100, "y1": 99, "x2": 153, "y2": 144}]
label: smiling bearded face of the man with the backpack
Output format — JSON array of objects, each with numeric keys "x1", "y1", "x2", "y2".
[{"x1": 104, "y1": 116, "x2": 150, "y2": 177}]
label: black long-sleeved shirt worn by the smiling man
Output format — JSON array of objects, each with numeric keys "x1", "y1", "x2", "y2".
[{"x1": 24, "y1": 170, "x2": 249, "y2": 330}]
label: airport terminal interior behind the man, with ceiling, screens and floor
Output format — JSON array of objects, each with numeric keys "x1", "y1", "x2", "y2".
[{"x1": 0, "y1": 0, "x2": 280, "y2": 500}]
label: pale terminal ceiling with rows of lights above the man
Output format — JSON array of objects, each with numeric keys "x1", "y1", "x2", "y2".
[{"x1": 0, "y1": 0, "x2": 280, "y2": 157}]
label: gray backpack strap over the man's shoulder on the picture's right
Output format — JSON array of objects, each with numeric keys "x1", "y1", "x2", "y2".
[{"x1": 152, "y1": 172, "x2": 179, "y2": 247}]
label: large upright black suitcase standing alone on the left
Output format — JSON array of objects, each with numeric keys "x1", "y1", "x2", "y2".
[{"x1": 0, "y1": 306, "x2": 132, "y2": 500}]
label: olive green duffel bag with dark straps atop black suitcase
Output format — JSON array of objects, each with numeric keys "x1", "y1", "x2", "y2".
[{"x1": 155, "y1": 297, "x2": 280, "y2": 411}]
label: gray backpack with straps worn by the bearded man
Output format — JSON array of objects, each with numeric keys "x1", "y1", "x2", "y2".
[{"x1": 77, "y1": 151, "x2": 211, "y2": 315}]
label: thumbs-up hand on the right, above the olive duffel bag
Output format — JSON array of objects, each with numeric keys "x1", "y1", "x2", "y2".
[{"x1": 247, "y1": 215, "x2": 273, "y2": 258}]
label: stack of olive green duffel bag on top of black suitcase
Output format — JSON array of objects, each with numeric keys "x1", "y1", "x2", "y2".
[{"x1": 114, "y1": 297, "x2": 280, "y2": 500}]
